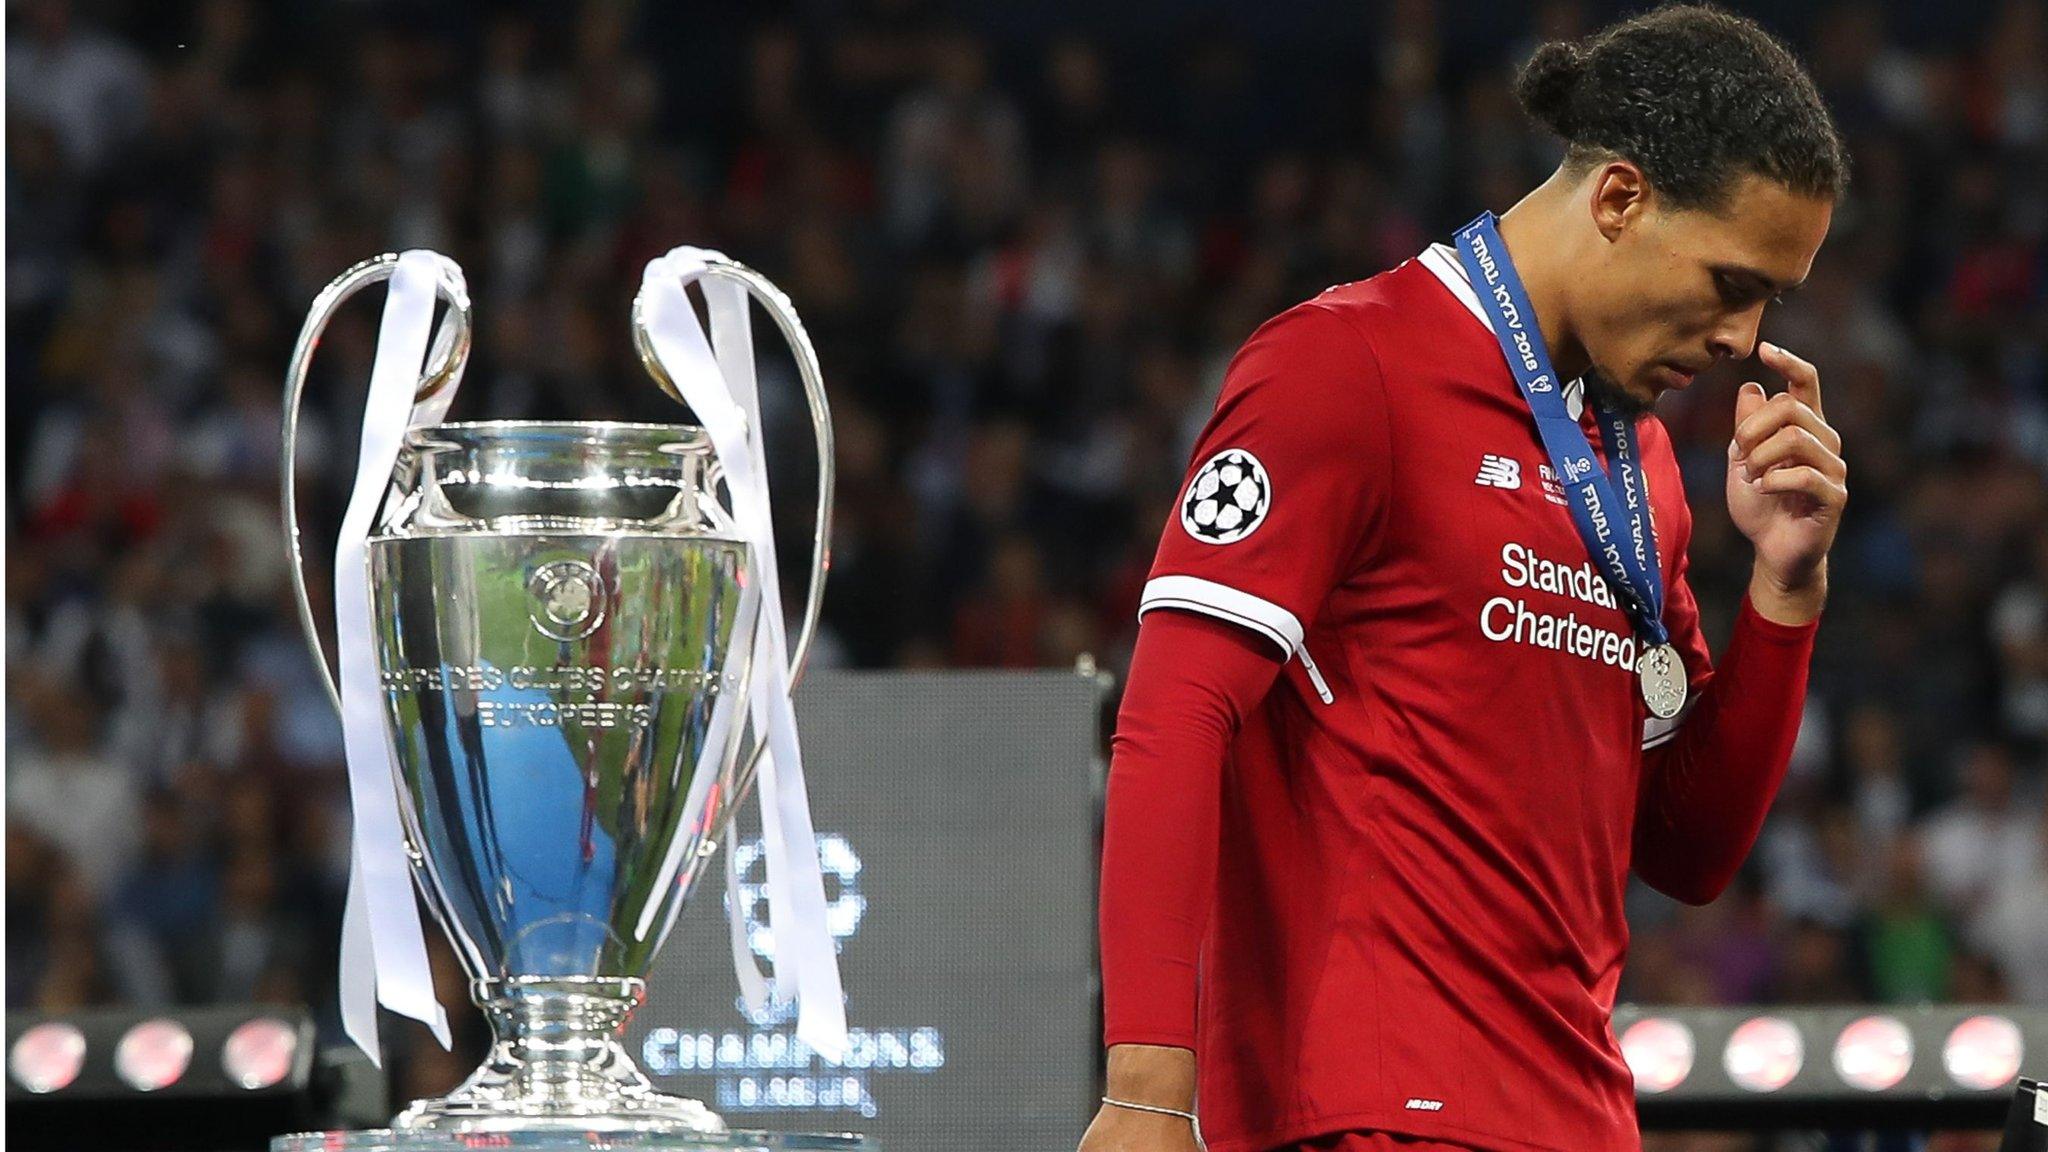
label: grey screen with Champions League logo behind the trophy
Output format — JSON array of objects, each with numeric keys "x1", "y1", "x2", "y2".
[{"x1": 627, "y1": 672, "x2": 1102, "y2": 1152}]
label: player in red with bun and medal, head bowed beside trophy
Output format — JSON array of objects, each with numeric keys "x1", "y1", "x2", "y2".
[{"x1": 1081, "y1": 6, "x2": 1847, "y2": 1152}]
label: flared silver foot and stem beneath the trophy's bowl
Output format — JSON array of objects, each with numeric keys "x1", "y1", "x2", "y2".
[{"x1": 393, "y1": 976, "x2": 725, "y2": 1134}]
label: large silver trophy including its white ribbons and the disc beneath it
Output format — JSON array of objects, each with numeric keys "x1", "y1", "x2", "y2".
[{"x1": 272, "y1": 248, "x2": 872, "y2": 1152}]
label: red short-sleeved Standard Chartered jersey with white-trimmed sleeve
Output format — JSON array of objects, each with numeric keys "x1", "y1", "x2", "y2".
[{"x1": 1141, "y1": 246, "x2": 1710, "y2": 1152}]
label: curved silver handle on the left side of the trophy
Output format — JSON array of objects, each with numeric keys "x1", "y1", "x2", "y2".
[{"x1": 281, "y1": 252, "x2": 471, "y2": 713}]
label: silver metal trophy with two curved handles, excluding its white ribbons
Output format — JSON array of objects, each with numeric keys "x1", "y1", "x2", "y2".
[{"x1": 279, "y1": 254, "x2": 864, "y2": 1148}]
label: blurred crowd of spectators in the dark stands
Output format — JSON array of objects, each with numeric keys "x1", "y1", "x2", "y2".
[{"x1": 6, "y1": 0, "x2": 2048, "y2": 1115}]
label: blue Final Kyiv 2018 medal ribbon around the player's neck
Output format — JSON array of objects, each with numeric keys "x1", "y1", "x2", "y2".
[{"x1": 1458, "y1": 211, "x2": 1671, "y2": 648}]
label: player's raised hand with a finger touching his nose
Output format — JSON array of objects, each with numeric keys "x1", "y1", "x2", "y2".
[{"x1": 1729, "y1": 342, "x2": 1849, "y2": 623}]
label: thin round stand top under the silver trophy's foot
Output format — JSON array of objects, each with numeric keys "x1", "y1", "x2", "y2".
[{"x1": 270, "y1": 1127, "x2": 881, "y2": 1152}]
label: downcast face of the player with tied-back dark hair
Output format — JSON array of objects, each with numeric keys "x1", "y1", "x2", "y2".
[{"x1": 1573, "y1": 174, "x2": 1833, "y2": 412}]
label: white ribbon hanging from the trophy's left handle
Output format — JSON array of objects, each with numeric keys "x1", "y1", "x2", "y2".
[{"x1": 334, "y1": 248, "x2": 463, "y2": 1062}]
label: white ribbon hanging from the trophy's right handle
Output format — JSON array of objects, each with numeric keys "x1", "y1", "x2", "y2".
[{"x1": 639, "y1": 248, "x2": 846, "y2": 1062}]
